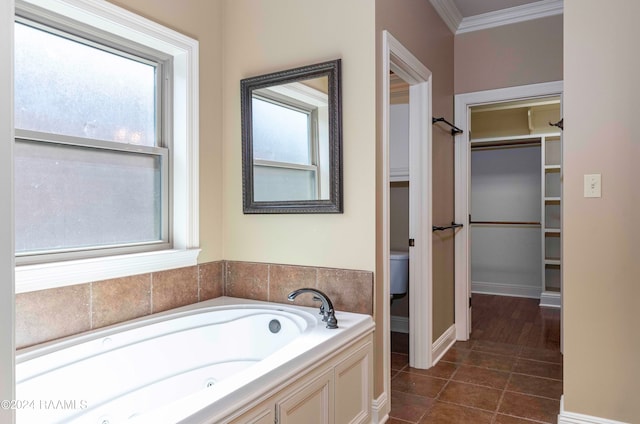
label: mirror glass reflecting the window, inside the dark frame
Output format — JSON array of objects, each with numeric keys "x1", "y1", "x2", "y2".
[{"x1": 252, "y1": 77, "x2": 329, "y2": 201}]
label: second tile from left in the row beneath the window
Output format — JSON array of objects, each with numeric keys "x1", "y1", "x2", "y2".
[{"x1": 91, "y1": 274, "x2": 151, "y2": 328}]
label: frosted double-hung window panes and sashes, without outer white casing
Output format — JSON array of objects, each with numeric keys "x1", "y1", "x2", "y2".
[{"x1": 14, "y1": 19, "x2": 171, "y2": 263}]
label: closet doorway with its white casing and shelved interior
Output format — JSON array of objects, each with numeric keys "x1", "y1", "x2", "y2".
[{"x1": 455, "y1": 82, "x2": 562, "y2": 340}]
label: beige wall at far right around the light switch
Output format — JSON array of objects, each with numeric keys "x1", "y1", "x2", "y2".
[{"x1": 562, "y1": 0, "x2": 640, "y2": 422}]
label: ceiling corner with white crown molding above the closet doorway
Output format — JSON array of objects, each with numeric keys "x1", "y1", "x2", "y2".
[{"x1": 429, "y1": 0, "x2": 564, "y2": 35}]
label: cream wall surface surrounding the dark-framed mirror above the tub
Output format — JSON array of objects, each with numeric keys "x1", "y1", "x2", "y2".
[{"x1": 222, "y1": 0, "x2": 376, "y2": 271}]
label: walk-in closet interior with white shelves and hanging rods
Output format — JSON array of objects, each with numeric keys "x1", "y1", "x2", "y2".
[{"x1": 470, "y1": 97, "x2": 562, "y2": 307}]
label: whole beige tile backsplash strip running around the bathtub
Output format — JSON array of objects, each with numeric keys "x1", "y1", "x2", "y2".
[{"x1": 16, "y1": 261, "x2": 373, "y2": 349}]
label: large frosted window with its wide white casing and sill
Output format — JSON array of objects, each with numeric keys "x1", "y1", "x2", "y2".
[{"x1": 14, "y1": 0, "x2": 199, "y2": 292}]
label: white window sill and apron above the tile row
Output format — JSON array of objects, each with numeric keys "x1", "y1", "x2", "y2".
[{"x1": 15, "y1": 249, "x2": 200, "y2": 293}]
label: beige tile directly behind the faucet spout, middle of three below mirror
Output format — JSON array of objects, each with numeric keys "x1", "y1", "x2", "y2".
[{"x1": 269, "y1": 265, "x2": 318, "y2": 306}]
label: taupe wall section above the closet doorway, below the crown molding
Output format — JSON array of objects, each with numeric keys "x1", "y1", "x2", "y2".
[{"x1": 455, "y1": 16, "x2": 562, "y2": 94}]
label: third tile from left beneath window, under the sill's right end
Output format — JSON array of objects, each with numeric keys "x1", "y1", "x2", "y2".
[{"x1": 151, "y1": 266, "x2": 198, "y2": 313}]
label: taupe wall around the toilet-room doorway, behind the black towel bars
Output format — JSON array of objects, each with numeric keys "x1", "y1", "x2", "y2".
[{"x1": 374, "y1": 0, "x2": 454, "y2": 396}]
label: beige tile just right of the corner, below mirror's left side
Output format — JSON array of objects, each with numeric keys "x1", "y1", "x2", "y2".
[{"x1": 224, "y1": 261, "x2": 269, "y2": 300}]
